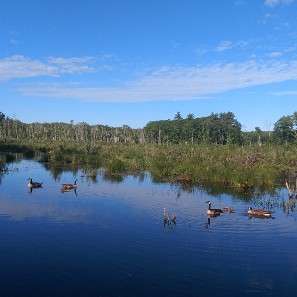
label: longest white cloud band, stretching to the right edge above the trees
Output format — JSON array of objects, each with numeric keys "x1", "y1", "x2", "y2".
[{"x1": 19, "y1": 60, "x2": 297, "y2": 102}]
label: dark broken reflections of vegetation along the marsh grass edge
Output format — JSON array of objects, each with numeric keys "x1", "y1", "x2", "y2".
[{"x1": 0, "y1": 152, "x2": 297, "y2": 208}]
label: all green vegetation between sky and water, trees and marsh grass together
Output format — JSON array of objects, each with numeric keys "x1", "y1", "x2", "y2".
[{"x1": 0, "y1": 113, "x2": 297, "y2": 195}]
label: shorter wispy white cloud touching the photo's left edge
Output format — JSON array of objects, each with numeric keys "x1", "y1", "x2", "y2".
[{"x1": 0, "y1": 55, "x2": 94, "y2": 81}]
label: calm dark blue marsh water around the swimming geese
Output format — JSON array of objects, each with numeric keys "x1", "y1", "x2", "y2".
[{"x1": 0, "y1": 160, "x2": 297, "y2": 297}]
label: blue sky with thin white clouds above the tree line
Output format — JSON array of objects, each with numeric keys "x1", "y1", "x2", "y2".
[{"x1": 0, "y1": 0, "x2": 297, "y2": 130}]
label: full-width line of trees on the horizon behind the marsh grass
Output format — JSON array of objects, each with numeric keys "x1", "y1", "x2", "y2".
[{"x1": 0, "y1": 112, "x2": 297, "y2": 145}]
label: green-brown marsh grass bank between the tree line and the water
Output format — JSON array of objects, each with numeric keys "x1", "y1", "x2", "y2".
[{"x1": 0, "y1": 143, "x2": 297, "y2": 193}]
